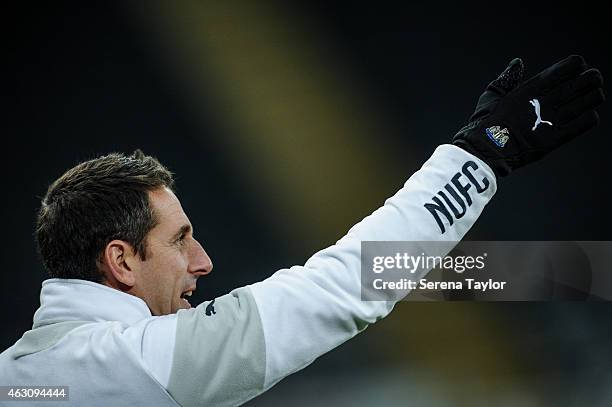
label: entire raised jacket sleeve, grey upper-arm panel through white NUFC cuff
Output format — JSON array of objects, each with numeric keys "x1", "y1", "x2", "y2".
[{"x1": 149, "y1": 145, "x2": 497, "y2": 406}]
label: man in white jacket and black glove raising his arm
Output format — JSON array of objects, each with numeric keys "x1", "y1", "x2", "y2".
[{"x1": 0, "y1": 56, "x2": 604, "y2": 406}]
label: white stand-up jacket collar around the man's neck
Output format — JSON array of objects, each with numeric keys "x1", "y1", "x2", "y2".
[{"x1": 33, "y1": 278, "x2": 151, "y2": 328}]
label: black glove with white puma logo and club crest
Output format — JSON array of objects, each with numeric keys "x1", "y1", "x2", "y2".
[{"x1": 453, "y1": 55, "x2": 605, "y2": 176}]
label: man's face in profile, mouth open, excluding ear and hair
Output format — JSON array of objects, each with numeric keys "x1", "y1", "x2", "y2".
[{"x1": 132, "y1": 188, "x2": 212, "y2": 315}]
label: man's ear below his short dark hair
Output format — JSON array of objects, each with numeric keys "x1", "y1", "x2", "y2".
[{"x1": 102, "y1": 240, "x2": 139, "y2": 288}]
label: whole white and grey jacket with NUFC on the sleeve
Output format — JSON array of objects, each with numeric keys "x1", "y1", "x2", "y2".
[{"x1": 0, "y1": 145, "x2": 497, "y2": 406}]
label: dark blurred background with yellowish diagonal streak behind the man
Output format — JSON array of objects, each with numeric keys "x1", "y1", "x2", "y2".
[{"x1": 0, "y1": 1, "x2": 612, "y2": 406}]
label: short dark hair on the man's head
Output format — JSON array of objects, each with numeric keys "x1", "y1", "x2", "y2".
[{"x1": 36, "y1": 150, "x2": 174, "y2": 282}]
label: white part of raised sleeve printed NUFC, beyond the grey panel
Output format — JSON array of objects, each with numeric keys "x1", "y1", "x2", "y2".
[{"x1": 246, "y1": 145, "x2": 496, "y2": 389}]
